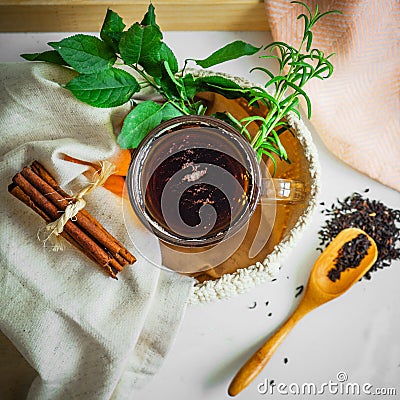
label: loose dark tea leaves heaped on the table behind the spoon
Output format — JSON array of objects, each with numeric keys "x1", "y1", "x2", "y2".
[{"x1": 318, "y1": 190, "x2": 400, "y2": 279}]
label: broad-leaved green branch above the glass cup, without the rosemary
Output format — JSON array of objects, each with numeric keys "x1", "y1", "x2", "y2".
[{"x1": 22, "y1": 3, "x2": 261, "y2": 148}]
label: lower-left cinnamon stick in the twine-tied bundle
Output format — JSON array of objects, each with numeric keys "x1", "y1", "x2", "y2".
[{"x1": 13, "y1": 173, "x2": 123, "y2": 278}]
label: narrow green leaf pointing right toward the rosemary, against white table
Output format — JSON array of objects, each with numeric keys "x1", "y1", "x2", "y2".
[{"x1": 193, "y1": 40, "x2": 261, "y2": 68}]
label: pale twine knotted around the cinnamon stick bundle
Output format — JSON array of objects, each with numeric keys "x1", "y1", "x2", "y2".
[{"x1": 38, "y1": 160, "x2": 116, "y2": 251}]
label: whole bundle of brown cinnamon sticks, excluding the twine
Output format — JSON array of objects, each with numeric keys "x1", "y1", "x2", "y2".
[{"x1": 8, "y1": 161, "x2": 136, "y2": 279}]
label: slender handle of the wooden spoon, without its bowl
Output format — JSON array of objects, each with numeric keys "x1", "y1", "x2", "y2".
[{"x1": 228, "y1": 302, "x2": 310, "y2": 396}]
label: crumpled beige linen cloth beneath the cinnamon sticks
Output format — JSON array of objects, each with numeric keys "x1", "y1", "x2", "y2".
[{"x1": 0, "y1": 63, "x2": 193, "y2": 400}]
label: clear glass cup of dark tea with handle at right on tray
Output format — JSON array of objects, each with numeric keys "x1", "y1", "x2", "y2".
[{"x1": 126, "y1": 115, "x2": 304, "y2": 247}]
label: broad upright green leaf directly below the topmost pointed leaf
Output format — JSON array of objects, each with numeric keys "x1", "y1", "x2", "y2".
[{"x1": 119, "y1": 22, "x2": 162, "y2": 76}]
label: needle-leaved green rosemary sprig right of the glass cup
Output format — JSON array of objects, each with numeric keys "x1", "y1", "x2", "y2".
[{"x1": 236, "y1": 1, "x2": 341, "y2": 168}]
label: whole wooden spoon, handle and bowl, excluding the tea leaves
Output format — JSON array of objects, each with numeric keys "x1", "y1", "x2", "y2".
[{"x1": 228, "y1": 228, "x2": 378, "y2": 396}]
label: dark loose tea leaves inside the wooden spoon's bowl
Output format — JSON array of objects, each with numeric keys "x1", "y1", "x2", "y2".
[{"x1": 328, "y1": 233, "x2": 371, "y2": 282}]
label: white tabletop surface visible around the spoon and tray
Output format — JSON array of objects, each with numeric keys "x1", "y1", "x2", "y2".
[{"x1": 0, "y1": 32, "x2": 400, "y2": 400}]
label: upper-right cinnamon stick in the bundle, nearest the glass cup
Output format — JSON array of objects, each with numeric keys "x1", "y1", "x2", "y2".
[{"x1": 30, "y1": 161, "x2": 136, "y2": 265}]
